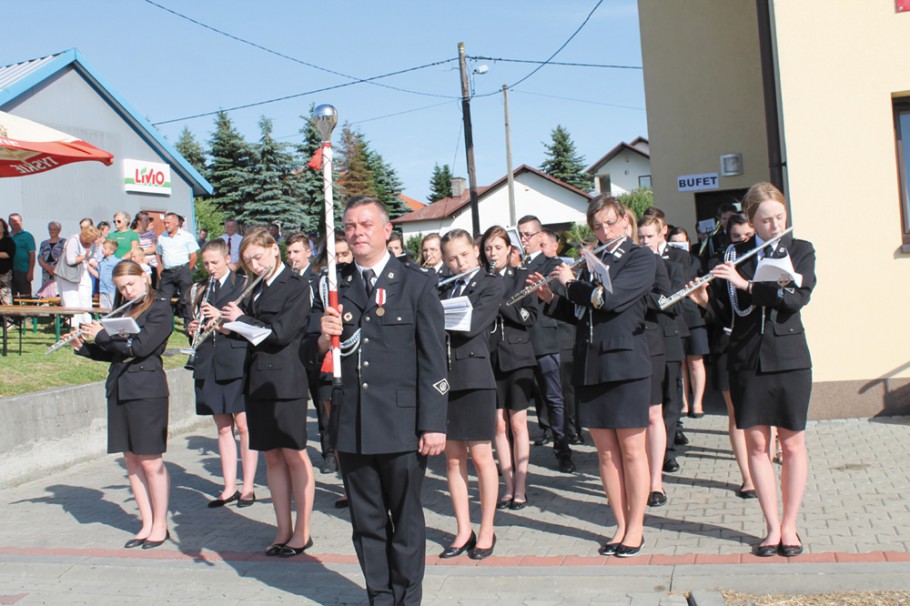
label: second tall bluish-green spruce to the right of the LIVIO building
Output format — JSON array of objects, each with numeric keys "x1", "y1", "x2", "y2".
[{"x1": 240, "y1": 116, "x2": 306, "y2": 231}]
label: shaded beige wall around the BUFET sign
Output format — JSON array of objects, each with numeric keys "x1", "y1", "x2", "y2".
[{"x1": 638, "y1": 0, "x2": 769, "y2": 230}]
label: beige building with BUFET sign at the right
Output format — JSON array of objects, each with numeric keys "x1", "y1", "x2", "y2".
[{"x1": 638, "y1": 0, "x2": 910, "y2": 418}]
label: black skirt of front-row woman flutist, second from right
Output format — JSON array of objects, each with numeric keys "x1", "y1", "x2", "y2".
[{"x1": 575, "y1": 377, "x2": 651, "y2": 429}]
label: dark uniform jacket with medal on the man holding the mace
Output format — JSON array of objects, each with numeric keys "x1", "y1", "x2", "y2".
[{"x1": 304, "y1": 258, "x2": 449, "y2": 454}]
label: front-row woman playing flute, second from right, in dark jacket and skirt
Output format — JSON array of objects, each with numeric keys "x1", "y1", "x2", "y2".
[{"x1": 532, "y1": 194, "x2": 657, "y2": 557}]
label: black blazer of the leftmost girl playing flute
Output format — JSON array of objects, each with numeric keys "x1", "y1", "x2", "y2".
[{"x1": 76, "y1": 298, "x2": 173, "y2": 402}]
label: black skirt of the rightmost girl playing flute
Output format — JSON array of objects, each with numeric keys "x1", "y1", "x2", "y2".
[{"x1": 730, "y1": 368, "x2": 812, "y2": 431}]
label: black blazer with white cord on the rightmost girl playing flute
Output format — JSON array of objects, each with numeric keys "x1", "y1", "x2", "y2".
[{"x1": 706, "y1": 234, "x2": 815, "y2": 372}]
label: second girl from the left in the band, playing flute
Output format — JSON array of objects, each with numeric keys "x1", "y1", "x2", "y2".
[{"x1": 187, "y1": 239, "x2": 259, "y2": 508}]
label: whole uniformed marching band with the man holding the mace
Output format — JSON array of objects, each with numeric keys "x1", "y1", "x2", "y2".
[{"x1": 70, "y1": 183, "x2": 815, "y2": 604}]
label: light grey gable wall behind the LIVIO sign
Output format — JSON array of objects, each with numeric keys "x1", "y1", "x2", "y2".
[{"x1": 0, "y1": 69, "x2": 194, "y2": 290}]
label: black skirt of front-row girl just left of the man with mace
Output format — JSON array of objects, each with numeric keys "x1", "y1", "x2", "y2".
[{"x1": 246, "y1": 398, "x2": 307, "y2": 451}]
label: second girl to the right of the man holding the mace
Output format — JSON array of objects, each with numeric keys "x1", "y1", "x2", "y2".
[{"x1": 483, "y1": 225, "x2": 538, "y2": 510}]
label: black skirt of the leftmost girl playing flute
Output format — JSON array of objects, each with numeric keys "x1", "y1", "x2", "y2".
[{"x1": 107, "y1": 397, "x2": 168, "y2": 455}]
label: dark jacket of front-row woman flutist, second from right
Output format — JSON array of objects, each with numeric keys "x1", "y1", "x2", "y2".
[{"x1": 544, "y1": 239, "x2": 657, "y2": 385}]
